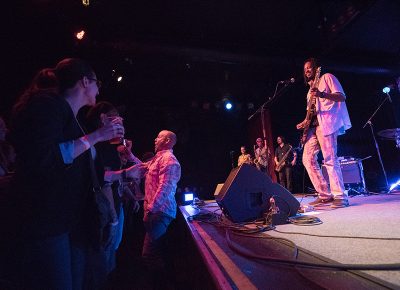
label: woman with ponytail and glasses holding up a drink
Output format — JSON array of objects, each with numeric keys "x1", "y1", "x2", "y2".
[{"x1": 3, "y1": 58, "x2": 124, "y2": 289}]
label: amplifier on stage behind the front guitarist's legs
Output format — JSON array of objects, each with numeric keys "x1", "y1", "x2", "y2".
[{"x1": 322, "y1": 158, "x2": 365, "y2": 188}]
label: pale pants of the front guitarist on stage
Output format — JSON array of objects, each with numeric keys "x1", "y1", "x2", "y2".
[{"x1": 303, "y1": 126, "x2": 347, "y2": 199}]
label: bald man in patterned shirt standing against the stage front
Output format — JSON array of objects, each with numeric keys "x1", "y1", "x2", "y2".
[{"x1": 142, "y1": 130, "x2": 181, "y2": 286}]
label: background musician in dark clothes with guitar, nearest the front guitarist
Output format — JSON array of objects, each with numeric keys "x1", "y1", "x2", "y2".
[{"x1": 274, "y1": 136, "x2": 297, "y2": 192}]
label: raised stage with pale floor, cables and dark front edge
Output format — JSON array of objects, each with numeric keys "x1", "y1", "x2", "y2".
[{"x1": 180, "y1": 192, "x2": 400, "y2": 289}]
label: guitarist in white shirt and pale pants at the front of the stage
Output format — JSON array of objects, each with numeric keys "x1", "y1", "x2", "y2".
[{"x1": 296, "y1": 58, "x2": 351, "y2": 208}]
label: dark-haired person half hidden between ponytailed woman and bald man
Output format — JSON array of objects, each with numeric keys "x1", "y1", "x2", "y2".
[{"x1": 76, "y1": 101, "x2": 131, "y2": 289}]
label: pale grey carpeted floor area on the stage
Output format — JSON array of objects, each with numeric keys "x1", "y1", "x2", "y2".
[{"x1": 274, "y1": 192, "x2": 400, "y2": 288}]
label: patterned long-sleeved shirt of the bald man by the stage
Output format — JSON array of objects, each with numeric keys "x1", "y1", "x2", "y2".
[{"x1": 144, "y1": 149, "x2": 181, "y2": 218}]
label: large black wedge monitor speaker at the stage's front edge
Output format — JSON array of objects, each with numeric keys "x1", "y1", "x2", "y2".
[{"x1": 215, "y1": 164, "x2": 300, "y2": 223}]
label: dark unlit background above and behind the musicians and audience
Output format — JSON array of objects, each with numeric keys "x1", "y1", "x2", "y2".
[{"x1": 0, "y1": 0, "x2": 400, "y2": 197}]
